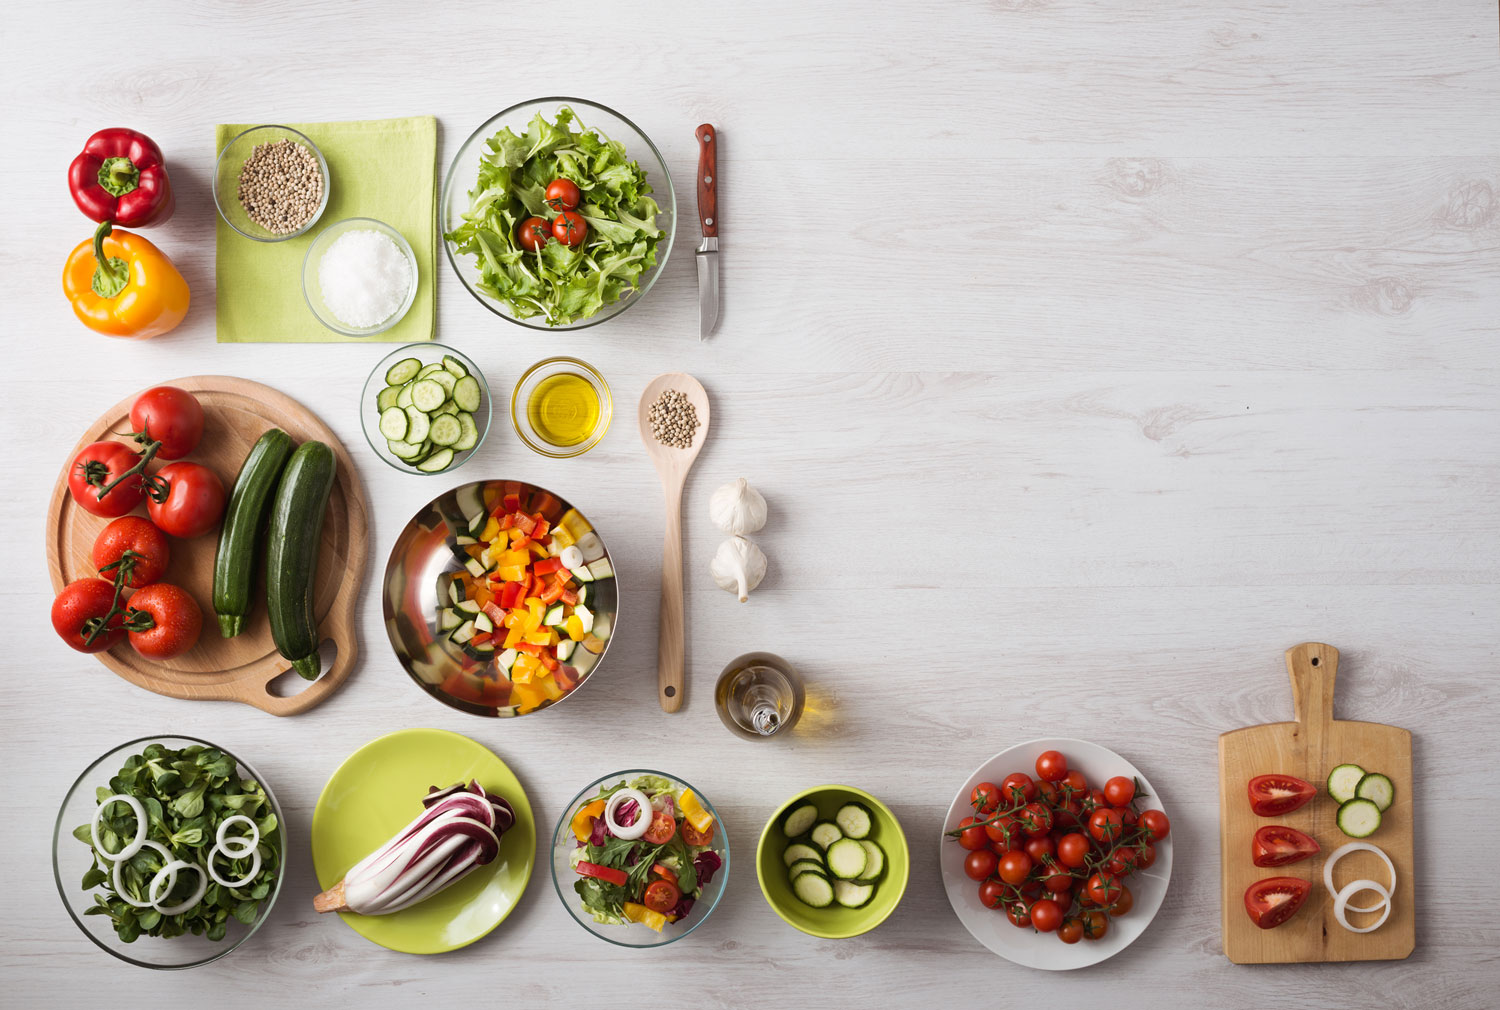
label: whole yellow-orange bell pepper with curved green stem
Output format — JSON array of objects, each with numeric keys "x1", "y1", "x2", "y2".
[{"x1": 63, "y1": 221, "x2": 189, "y2": 341}]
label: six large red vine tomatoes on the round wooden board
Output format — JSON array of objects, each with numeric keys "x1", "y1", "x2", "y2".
[{"x1": 53, "y1": 386, "x2": 216, "y2": 659}]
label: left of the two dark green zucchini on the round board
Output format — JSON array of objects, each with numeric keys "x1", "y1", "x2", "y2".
[{"x1": 213, "y1": 428, "x2": 293, "y2": 638}]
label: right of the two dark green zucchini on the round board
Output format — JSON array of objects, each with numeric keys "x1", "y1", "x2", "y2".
[{"x1": 266, "y1": 441, "x2": 336, "y2": 680}]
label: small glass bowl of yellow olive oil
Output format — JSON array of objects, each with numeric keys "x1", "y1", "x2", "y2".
[{"x1": 510, "y1": 357, "x2": 615, "y2": 459}]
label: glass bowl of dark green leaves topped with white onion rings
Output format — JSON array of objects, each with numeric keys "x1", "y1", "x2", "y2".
[{"x1": 53, "y1": 737, "x2": 287, "y2": 969}]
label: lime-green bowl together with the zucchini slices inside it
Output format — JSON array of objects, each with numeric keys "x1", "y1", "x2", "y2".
[{"x1": 756, "y1": 785, "x2": 911, "y2": 939}]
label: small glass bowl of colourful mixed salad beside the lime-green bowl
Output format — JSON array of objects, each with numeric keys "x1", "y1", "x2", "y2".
[{"x1": 552, "y1": 768, "x2": 729, "y2": 947}]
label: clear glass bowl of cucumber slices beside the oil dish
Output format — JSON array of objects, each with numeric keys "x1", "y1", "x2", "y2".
[{"x1": 360, "y1": 344, "x2": 491, "y2": 474}]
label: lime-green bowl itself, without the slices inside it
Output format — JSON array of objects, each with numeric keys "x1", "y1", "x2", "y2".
[{"x1": 755, "y1": 785, "x2": 911, "y2": 939}]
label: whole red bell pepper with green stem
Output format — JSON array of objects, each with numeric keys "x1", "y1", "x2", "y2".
[{"x1": 68, "y1": 128, "x2": 177, "y2": 228}]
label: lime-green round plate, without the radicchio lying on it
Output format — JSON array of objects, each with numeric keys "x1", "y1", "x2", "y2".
[{"x1": 312, "y1": 729, "x2": 537, "y2": 954}]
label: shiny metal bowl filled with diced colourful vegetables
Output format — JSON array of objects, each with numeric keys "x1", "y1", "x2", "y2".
[{"x1": 381, "y1": 480, "x2": 620, "y2": 717}]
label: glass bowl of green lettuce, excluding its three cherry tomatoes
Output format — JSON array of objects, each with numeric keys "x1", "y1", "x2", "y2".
[{"x1": 441, "y1": 98, "x2": 677, "y2": 330}]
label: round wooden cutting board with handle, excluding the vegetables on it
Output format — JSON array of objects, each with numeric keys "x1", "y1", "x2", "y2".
[{"x1": 47, "y1": 375, "x2": 369, "y2": 716}]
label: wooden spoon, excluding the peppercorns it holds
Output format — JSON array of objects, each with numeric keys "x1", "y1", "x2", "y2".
[{"x1": 639, "y1": 372, "x2": 708, "y2": 711}]
